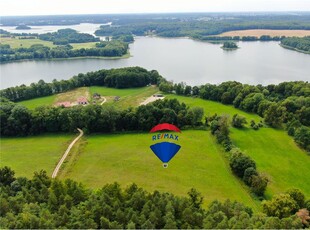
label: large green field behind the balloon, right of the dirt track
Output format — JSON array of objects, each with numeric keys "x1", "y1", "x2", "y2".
[{"x1": 61, "y1": 130, "x2": 259, "y2": 209}]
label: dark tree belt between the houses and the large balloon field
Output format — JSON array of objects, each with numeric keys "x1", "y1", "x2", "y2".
[{"x1": 0, "y1": 99, "x2": 203, "y2": 136}]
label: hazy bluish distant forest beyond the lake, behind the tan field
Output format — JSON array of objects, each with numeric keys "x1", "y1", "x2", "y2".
[{"x1": 96, "y1": 14, "x2": 310, "y2": 39}]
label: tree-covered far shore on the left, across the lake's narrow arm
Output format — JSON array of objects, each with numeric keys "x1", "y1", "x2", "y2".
[{"x1": 0, "y1": 40, "x2": 128, "y2": 63}]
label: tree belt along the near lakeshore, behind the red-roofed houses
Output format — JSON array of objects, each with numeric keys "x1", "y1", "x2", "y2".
[{"x1": 0, "y1": 67, "x2": 163, "y2": 102}]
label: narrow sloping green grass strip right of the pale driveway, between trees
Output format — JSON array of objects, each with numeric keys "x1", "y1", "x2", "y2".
[{"x1": 166, "y1": 94, "x2": 263, "y2": 123}]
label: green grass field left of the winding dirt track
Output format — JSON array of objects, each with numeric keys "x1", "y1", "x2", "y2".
[{"x1": 0, "y1": 134, "x2": 73, "y2": 178}]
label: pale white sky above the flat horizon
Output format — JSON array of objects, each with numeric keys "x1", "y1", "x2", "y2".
[{"x1": 0, "y1": 0, "x2": 310, "y2": 16}]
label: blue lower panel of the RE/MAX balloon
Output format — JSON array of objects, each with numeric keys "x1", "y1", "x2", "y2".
[{"x1": 150, "y1": 142, "x2": 181, "y2": 163}]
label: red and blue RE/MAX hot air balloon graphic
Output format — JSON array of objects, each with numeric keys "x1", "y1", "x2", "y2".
[{"x1": 150, "y1": 123, "x2": 181, "y2": 168}]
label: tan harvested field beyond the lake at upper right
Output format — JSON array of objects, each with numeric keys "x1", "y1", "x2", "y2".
[{"x1": 218, "y1": 30, "x2": 310, "y2": 37}]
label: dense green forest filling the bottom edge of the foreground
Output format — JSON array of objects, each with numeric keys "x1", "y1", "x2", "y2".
[{"x1": 0, "y1": 167, "x2": 310, "y2": 229}]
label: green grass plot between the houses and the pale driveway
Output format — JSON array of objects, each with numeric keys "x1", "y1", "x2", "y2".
[{"x1": 90, "y1": 86, "x2": 159, "y2": 108}]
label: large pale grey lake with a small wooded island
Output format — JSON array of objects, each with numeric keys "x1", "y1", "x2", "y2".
[{"x1": 0, "y1": 37, "x2": 310, "y2": 88}]
